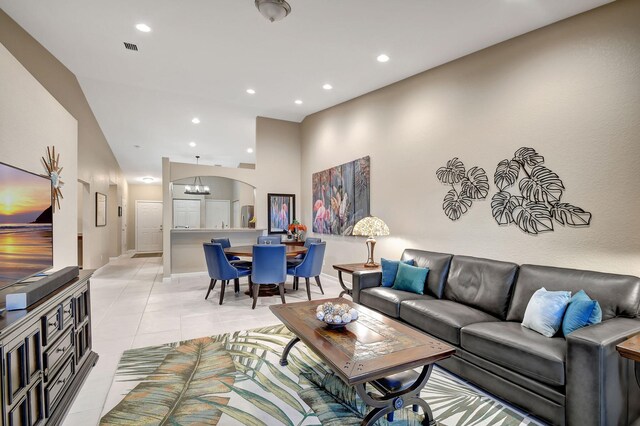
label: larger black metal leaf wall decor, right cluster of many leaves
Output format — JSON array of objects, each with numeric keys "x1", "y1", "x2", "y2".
[{"x1": 491, "y1": 147, "x2": 591, "y2": 235}]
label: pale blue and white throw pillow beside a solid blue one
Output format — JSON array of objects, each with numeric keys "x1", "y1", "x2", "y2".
[{"x1": 522, "y1": 287, "x2": 571, "y2": 337}]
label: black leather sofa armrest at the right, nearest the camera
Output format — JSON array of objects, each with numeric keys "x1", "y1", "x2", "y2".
[{"x1": 566, "y1": 318, "x2": 640, "y2": 425}]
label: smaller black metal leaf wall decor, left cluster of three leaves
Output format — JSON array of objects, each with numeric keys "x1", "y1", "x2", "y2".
[{"x1": 436, "y1": 157, "x2": 489, "y2": 220}]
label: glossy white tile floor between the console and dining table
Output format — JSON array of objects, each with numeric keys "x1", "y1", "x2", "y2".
[{"x1": 63, "y1": 255, "x2": 348, "y2": 426}]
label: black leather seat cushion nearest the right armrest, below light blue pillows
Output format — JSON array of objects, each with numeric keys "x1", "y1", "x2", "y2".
[{"x1": 460, "y1": 322, "x2": 567, "y2": 386}]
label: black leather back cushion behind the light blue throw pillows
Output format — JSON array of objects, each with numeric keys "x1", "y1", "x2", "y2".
[{"x1": 507, "y1": 265, "x2": 640, "y2": 322}]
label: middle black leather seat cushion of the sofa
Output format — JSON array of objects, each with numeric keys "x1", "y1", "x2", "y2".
[{"x1": 400, "y1": 300, "x2": 497, "y2": 346}]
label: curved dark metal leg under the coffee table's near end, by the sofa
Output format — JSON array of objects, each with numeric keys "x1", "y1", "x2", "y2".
[{"x1": 356, "y1": 364, "x2": 437, "y2": 426}]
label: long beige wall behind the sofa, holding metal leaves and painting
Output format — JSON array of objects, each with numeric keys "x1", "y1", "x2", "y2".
[{"x1": 301, "y1": 0, "x2": 640, "y2": 275}]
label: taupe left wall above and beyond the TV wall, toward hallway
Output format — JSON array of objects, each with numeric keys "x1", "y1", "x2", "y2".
[{"x1": 0, "y1": 10, "x2": 127, "y2": 268}]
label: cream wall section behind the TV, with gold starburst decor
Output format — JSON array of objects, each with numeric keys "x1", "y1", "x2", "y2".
[{"x1": 0, "y1": 41, "x2": 78, "y2": 269}]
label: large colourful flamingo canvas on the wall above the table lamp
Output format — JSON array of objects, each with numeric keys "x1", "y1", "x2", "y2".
[{"x1": 311, "y1": 157, "x2": 371, "y2": 235}]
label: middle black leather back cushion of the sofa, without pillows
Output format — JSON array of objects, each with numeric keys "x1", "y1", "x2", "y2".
[{"x1": 443, "y1": 256, "x2": 520, "y2": 320}]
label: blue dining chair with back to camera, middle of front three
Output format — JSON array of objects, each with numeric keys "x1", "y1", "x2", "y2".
[{"x1": 249, "y1": 244, "x2": 287, "y2": 309}]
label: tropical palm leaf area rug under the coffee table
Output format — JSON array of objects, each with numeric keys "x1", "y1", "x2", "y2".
[{"x1": 100, "y1": 325, "x2": 531, "y2": 426}]
